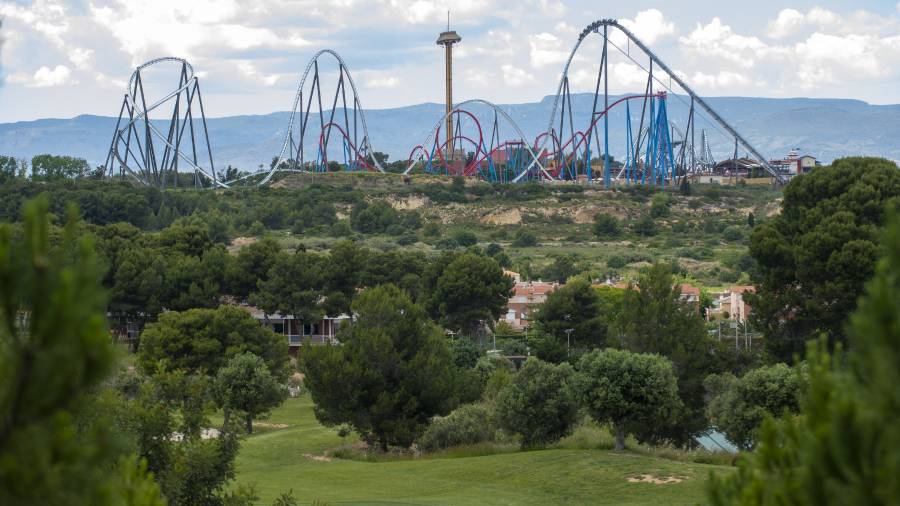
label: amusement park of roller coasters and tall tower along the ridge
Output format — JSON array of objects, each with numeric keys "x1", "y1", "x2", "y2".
[{"x1": 106, "y1": 19, "x2": 784, "y2": 187}]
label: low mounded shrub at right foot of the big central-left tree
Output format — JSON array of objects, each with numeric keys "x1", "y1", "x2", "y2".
[{"x1": 418, "y1": 404, "x2": 495, "y2": 452}]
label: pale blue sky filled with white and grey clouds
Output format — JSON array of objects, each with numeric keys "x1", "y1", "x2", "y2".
[{"x1": 0, "y1": 0, "x2": 900, "y2": 122}]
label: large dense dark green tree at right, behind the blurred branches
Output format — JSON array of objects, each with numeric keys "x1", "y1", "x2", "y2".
[{"x1": 745, "y1": 158, "x2": 900, "y2": 363}]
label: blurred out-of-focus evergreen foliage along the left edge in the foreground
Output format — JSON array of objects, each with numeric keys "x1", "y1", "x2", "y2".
[{"x1": 0, "y1": 198, "x2": 163, "y2": 505}]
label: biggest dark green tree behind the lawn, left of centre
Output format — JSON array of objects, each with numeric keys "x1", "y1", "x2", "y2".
[{"x1": 301, "y1": 285, "x2": 459, "y2": 451}]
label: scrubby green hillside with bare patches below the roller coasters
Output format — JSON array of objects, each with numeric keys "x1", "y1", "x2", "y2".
[{"x1": 0, "y1": 173, "x2": 780, "y2": 286}]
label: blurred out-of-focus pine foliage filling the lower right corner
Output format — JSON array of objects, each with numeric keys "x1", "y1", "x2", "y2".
[{"x1": 709, "y1": 211, "x2": 900, "y2": 505}]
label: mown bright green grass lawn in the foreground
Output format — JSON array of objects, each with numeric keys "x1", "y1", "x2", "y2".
[{"x1": 237, "y1": 396, "x2": 727, "y2": 506}]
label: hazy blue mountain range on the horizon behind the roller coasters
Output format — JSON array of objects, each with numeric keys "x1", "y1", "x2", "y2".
[{"x1": 0, "y1": 94, "x2": 900, "y2": 170}]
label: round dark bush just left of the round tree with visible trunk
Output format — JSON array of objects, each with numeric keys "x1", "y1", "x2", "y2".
[{"x1": 497, "y1": 358, "x2": 578, "y2": 448}]
